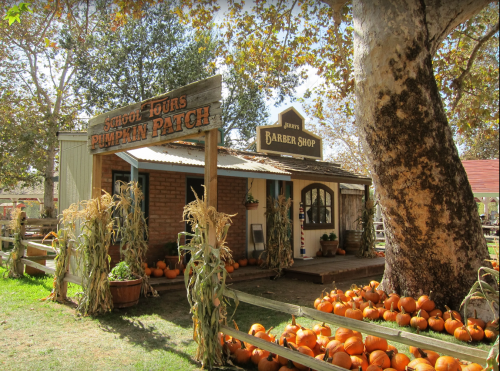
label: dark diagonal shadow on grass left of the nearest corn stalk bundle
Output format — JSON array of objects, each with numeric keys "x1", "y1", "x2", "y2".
[{"x1": 97, "y1": 312, "x2": 200, "y2": 367}]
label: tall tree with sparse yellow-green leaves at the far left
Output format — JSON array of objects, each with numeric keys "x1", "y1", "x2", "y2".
[{"x1": 0, "y1": 0, "x2": 99, "y2": 217}]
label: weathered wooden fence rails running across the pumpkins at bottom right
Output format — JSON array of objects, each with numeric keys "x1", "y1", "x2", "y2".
[{"x1": 222, "y1": 289, "x2": 488, "y2": 370}]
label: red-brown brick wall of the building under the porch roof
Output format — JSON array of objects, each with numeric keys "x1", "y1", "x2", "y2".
[{"x1": 101, "y1": 154, "x2": 246, "y2": 264}]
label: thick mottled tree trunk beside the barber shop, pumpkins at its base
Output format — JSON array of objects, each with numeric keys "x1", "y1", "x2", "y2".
[{"x1": 353, "y1": 0, "x2": 488, "y2": 308}]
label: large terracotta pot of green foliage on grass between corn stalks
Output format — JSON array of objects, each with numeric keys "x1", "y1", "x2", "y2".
[{"x1": 108, "y1": 261, "x2": 142, "y2": 308}]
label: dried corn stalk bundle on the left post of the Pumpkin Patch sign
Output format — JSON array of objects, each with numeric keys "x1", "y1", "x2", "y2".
[{"x1": 76, "y1": 192, "x2": 115, "y2": 316}]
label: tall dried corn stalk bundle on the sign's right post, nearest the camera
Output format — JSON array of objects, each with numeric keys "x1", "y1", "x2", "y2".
[{"x1": 178, "y1": 190, "x2": 234, "y2": 369}]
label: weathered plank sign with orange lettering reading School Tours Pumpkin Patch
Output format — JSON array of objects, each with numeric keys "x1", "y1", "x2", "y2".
[{"x1": 88, "y1": 75, "x2": 222, "y2": 154}]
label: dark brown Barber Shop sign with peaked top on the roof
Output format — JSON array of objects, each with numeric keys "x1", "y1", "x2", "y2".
[{"x1": 257, "y1": 107, "x2": 323, "y2": 160}]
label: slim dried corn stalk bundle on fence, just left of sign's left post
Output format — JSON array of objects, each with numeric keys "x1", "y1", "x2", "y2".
[{"x1": 43, "y1": 204, "x2": 78, "y2": 302}]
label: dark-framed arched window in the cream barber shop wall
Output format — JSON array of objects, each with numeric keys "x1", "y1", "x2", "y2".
[{"x1": 302, "y1": 183, "x2": 334, "y2": 229}]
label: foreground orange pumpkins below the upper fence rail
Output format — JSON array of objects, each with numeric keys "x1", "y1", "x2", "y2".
[{"x1": 219, "y1": 316, "x2": 483, "y2": 371}]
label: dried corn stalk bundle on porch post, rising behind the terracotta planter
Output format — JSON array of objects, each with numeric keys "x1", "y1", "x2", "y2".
[{"x1": 115, "y1": 181, "x2": 158, "y2": 296}]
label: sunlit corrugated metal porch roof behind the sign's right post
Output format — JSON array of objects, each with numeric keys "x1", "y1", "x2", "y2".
[{"x1": 127, "y1": 144, "x2": 290, "y2": 175}]
